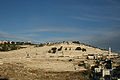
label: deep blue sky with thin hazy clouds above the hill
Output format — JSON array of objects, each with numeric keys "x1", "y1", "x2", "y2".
[{"x1": 0, "y1": 0, "x2": 120, "y2": 51}]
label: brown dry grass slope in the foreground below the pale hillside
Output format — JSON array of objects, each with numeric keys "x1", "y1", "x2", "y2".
[{"x1": 0, "y1": 63, "x2": 89, "y2": 80}]
